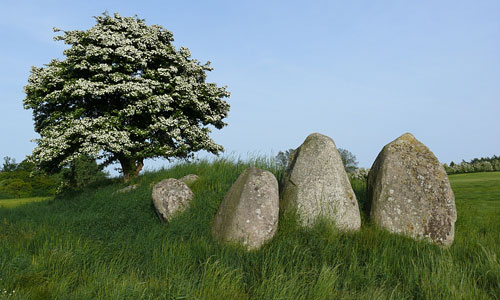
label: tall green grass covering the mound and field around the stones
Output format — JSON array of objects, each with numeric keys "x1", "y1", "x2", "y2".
[{"x1": 0, "y1": 159, "x2": 500, "y2": 300}]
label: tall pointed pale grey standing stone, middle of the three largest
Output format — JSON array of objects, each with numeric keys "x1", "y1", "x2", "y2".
[{"x1": 280, "y1": 133, "x2": 361, "y2": 230}]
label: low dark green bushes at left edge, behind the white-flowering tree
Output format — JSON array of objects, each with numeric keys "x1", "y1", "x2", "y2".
[{"x1": 0, "y1": 156, "x2": 108, "y2": 199}]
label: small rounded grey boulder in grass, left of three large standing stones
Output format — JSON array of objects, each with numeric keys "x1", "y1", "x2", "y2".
[{"x1": 152, "y1": 178, "x2": 193, "y2": 222}]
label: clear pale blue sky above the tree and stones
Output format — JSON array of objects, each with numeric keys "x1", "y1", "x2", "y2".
[{"x1": 0, "y1": 0, "x2": 500, "y2": 173}]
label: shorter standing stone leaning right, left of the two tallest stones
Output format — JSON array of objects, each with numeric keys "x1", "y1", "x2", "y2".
[{"x1": 212, "y1": 167, "x2": 279, "y2": 249}]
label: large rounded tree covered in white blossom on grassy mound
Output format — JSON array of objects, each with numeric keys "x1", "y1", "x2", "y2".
[{"x1": 23, "y1": 13, "x2": 229, "y2": 181}]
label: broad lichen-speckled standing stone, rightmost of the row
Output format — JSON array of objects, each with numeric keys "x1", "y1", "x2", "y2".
[{"x1": 368, "y1": 133, "x2": 457, "y2": 246}]
